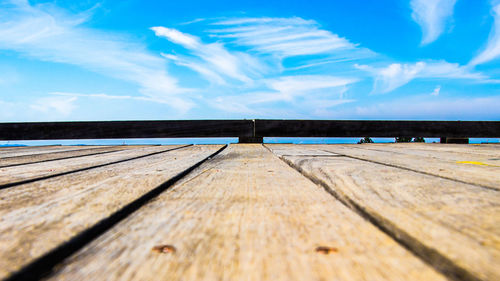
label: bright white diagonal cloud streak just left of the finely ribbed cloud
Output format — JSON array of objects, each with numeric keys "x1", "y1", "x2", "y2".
[{"x1": 151, "y1": 26, "x2": 262, "y2": 83}]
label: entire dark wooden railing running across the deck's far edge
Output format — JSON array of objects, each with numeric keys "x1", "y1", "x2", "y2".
[{"x1": 0, "y1": 119, "x2": 500, "y2": 142}]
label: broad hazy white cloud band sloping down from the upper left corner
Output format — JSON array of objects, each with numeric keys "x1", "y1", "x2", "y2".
[{"x1": 0, "y1": 0, "x2": 191, "y2": 110}]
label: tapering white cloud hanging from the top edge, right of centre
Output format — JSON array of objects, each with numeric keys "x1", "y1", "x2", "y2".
[{"x1": 410, "y1": 0, "x2": 456, "y2": 45}]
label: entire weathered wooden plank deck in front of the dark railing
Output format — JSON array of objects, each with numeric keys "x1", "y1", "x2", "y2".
[{"x1": 0, "y1": 143, "x2": 500, "y2": 281}]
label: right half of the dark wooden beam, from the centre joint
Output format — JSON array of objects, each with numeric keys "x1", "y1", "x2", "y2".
[{"x1": 255, "y1": 120, "x2": 500, "y2": 138}]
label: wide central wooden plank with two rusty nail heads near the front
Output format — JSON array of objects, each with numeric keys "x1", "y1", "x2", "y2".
[{"x1": 46, "y1": 144, "x2": 443, "y2": 280}]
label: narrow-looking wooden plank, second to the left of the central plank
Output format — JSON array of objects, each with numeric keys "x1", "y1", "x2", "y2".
[{"x1": 0, "y1": 145, "x2": 186, "y2": 189}]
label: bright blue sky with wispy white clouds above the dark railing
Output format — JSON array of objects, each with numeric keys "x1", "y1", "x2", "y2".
[{"x1": 0, "y1": 0, "x2": 500, "y2": 122}]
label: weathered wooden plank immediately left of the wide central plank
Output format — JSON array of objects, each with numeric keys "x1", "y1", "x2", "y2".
[{"x1": 0, "y1": 145, "x2": 222, "y2": 280}]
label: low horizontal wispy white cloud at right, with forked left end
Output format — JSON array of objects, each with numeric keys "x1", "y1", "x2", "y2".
[{"x1": 355, "y1": 61, "x2": 488, "y2": 93}]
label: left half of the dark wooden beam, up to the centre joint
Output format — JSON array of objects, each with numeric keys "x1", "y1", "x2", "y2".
[{"x1": 0, "y1": 120, "x2": 253, "y2": 140}]
